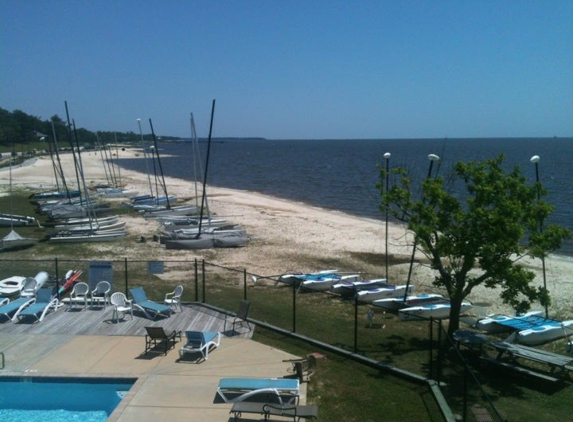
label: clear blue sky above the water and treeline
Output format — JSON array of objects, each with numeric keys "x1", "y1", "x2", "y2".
[{"x1": 0, "y1": 0, "x2": 573, "y2": 139}]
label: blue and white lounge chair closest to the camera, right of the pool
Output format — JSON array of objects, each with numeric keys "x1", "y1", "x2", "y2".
[{"x1": 217, "y1": 378, "x2": 299, "y2": 404}]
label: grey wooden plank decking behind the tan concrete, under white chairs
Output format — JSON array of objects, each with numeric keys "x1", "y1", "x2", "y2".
[{"x1": 0, "y1": 303, "x2": 253, "y2": 338}]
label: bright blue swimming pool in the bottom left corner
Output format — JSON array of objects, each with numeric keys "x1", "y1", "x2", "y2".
[{"x1": 0, "y1": 377, "x2": 136, "y2": 422}]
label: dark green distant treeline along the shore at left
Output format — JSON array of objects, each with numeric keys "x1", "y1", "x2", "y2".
[{"x1": 0, "y1": 107, "x2": 179, "y2": 151}]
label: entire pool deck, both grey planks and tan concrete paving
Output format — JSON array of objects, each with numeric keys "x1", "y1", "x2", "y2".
[{"x1": 0, "y1": 304, "x2": 306, "y2": 422}]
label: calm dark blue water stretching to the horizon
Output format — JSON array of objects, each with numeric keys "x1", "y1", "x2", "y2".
[{"x1": 120, "y1": 138, "x2": 573, "y2": 256}]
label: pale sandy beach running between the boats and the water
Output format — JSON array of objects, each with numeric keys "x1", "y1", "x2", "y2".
[{"x1": 0, "y1": 149, "x2": 573, "y2": 319}]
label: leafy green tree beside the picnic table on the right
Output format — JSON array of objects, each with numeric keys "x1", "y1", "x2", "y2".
[{"x1": 378, "y1": 154, "x2": 571, "y2": 335}]
